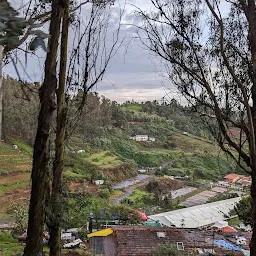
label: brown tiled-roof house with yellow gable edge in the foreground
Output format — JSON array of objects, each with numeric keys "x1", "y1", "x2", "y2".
[{"x1": 88, "y1": 225, "x2": 246, "y2": 256}]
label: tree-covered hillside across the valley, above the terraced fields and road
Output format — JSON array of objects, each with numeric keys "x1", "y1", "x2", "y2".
[{"x1": 1, "y1": 78, "x2": 241, "y2": 182}]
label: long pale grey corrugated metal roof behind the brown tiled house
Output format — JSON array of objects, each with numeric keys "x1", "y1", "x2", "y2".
[{"x1": 148, "y1": 197, "x2": 241, "y2": 228}]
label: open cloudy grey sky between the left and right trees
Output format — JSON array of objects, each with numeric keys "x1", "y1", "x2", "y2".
[{"x1": 94, "y1": 0, "x2": 172, "y2": 102}]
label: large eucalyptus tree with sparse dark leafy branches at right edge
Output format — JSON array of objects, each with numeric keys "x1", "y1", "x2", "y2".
[{"x1": 137, "y1": 0, "x2": 256, "y2": 255}]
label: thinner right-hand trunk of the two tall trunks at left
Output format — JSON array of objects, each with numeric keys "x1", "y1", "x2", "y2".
[{"x1": 49, "y1": 0, "x2": 69, "y2": 256}]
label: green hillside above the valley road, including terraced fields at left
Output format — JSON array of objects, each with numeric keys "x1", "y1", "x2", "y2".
[{"x1": 0, "y1": 88, "x2": 244, "y2": 218}]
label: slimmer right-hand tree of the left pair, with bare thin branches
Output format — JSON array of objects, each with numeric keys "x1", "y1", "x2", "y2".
[{"x1": 47, "y1": 0, "x2": 122, "y2": 256}]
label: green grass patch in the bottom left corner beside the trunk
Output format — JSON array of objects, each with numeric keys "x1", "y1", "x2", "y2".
[{"x1": 0, "y1": 231, "x2": 24, "y2": 256}]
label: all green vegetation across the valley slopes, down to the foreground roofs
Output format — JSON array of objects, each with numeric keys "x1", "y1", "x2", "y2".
[{"x1": 0, "y1": 78, "x2": 248, "y2": 254}]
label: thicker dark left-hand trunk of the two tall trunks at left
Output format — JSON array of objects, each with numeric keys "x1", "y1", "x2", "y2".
[{"x1": 23, "y1": 0, "x2": 62, "y2": 256}]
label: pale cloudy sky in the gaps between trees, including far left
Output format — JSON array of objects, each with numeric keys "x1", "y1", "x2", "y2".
[{"x1": 4, "y1": 0, "x2": 176, "y2": 103}]
